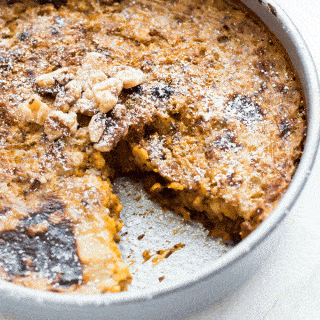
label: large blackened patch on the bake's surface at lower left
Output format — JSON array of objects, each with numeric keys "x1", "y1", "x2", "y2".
[{"x1": 0, "y1": 200, "x2": 82, "y2": 285}]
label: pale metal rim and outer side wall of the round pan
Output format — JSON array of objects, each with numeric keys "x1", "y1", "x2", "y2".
[{"x1": 0, "y1": 0, "x2": 320, "y2": 320}]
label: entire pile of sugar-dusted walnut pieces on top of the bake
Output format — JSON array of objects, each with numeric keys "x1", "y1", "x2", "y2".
[{"x1": 29, "y1": 52, "x2": 146, "y2": 146}]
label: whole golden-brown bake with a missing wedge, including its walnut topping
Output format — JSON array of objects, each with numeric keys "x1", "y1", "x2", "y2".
[{"x1": 0, "y1": 0, "x2": 306, "y2": 293}]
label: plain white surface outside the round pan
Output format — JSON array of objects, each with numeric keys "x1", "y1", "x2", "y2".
[{"x1": 190, "y1": 0, "x2": 320, "y2": 320}]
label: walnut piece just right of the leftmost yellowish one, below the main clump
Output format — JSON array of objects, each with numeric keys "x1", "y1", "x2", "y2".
[{"x1": 44, "y1": 110, "x2": 78, "y2": 141}]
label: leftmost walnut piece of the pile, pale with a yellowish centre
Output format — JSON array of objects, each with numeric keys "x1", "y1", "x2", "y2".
[{"x1": 18, "y1": 94, "x2": 51, "y2": 125}]
